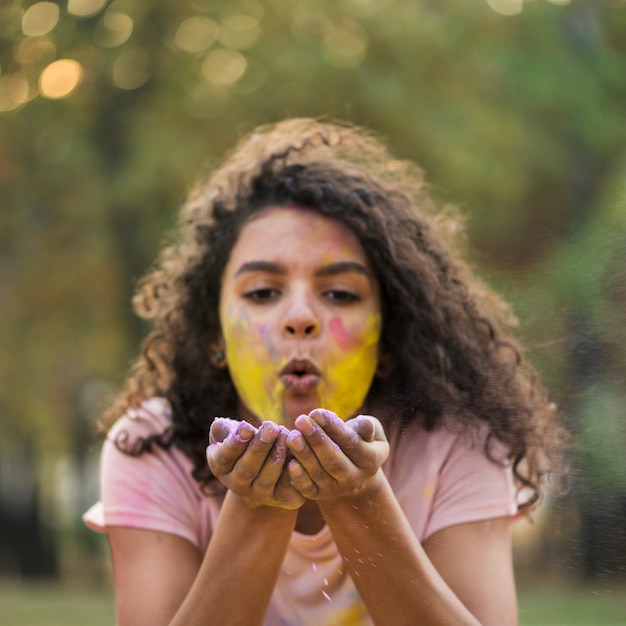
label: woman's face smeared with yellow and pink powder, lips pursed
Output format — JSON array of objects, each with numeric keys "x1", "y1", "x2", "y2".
[{"x1": 220, "y1": 207, "x2": 381, "y2": 428}]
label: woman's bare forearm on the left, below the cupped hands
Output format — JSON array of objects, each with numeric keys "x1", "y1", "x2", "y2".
[{"x1": 172, "y1": 491, "x2": 297, "y2": 626}]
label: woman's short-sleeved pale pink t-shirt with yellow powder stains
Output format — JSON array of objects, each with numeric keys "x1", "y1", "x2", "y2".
[{"x1": 83, "y1": 399, "x2": 517, "y2": 626}]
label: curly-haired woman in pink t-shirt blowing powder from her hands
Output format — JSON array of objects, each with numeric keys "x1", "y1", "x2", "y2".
[{"x1": 85, "y1": 120, "x2": 562, "y2": 626}]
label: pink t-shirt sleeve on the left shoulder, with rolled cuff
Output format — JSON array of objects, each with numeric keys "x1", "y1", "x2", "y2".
[{"x1": 83, "y1": 420, "x2": 200, "y2": 547}]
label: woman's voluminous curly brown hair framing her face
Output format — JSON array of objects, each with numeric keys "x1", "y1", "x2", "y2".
[{"x1": 108, "y1": 119, "x2": 565, "y2": 507}]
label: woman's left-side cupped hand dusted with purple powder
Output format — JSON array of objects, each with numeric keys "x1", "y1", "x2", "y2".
[{"x1": 207, "y1": 418, "x2": 304, "y2": 509}]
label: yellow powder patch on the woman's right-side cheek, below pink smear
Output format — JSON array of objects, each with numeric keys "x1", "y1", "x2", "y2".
[{"x1": 319, "y1": 314, "x2": 381, "y2": 420}]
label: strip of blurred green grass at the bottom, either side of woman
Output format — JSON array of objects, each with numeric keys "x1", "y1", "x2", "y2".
[{"x1": 0, "y1": 582, "x2": 626, "y2": 626}]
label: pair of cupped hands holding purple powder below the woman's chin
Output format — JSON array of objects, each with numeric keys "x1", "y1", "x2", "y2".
[{"x1": 207, "y1": 409, "x2": 389, "y2": 509}]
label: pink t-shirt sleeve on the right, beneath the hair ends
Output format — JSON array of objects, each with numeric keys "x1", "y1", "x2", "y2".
[{"x1": 424, "y1": 426, "x2": 517, "y2": 537}]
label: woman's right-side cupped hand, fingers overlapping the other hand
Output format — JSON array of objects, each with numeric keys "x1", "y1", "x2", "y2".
[{"x1": 287, "y1": 409, "x2": 389, "y2": 500}]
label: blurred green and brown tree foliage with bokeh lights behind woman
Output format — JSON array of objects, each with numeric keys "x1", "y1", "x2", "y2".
[{"x1": 0, "y1": 0, "x2": 626, "y2": 592}]
